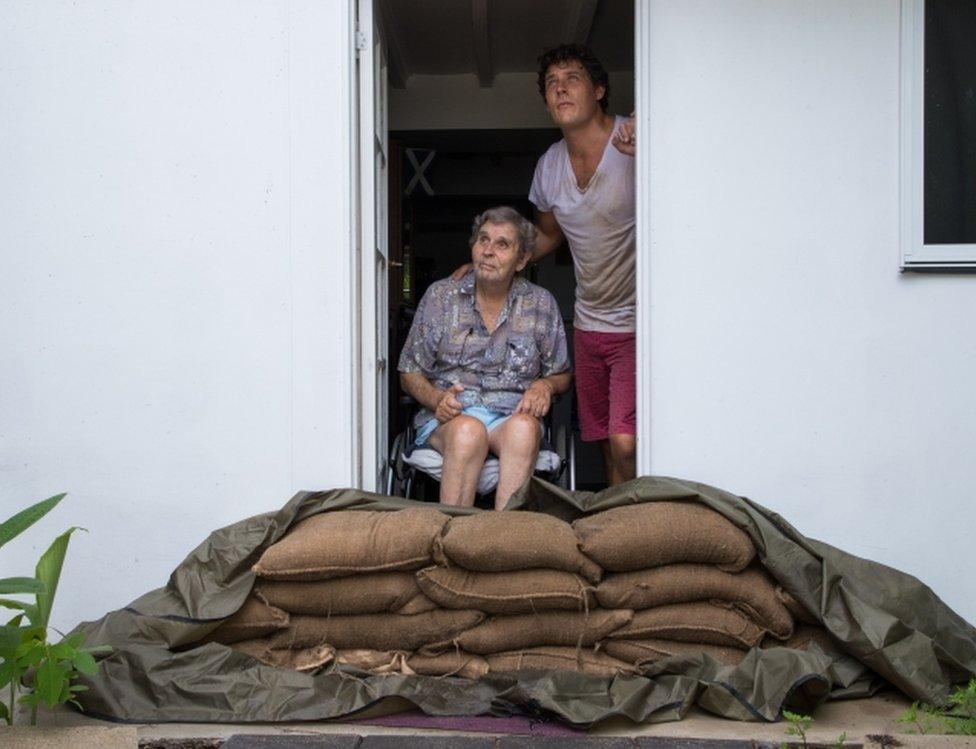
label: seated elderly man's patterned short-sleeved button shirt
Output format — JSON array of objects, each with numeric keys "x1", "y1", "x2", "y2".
[{"x1": 398, "y1": 271, "x2": 569, "y2": 426}]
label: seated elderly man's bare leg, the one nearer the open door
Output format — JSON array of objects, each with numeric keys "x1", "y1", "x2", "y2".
[{"x1": 430, "y1": 415, "x2": 488, "y2": 507}]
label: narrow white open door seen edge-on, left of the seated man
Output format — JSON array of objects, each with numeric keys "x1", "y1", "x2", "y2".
[{"x1": 356, "y1": 0, "x2": 392, "y2": 491}]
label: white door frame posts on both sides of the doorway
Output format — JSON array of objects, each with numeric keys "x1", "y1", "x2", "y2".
[{"x1": 350, "y1": 0, "x2": 652, "y2": 491}]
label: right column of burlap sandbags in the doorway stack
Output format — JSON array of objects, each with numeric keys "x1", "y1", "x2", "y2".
[{"x1": 573, "y1": 502, "x2": 793, "y2": 667}]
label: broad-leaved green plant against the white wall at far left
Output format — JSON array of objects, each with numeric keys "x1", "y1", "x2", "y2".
[{"x1": 0, "y1": 494, "x2": 111, "y2": 725}]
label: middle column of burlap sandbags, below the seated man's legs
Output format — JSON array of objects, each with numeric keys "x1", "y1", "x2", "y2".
[{"x1": 417, "y1": 512, "x2": 634, "y2": 676}]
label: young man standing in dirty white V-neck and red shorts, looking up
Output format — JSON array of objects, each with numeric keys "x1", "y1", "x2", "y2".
[{"x1": 529, "y1": 44, "x2": 637, "y2": 485}]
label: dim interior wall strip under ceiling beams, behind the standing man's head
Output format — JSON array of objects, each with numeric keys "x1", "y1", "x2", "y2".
[{"x1": 390, "y1": 72, "x2": 634, "y2": 130}]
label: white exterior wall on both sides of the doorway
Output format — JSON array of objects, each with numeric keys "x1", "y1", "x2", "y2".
[{"x1": 0, "y1": 0, "x2": 976, "y2": 627}]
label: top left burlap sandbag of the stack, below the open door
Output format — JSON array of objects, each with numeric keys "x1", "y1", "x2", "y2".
[{"x1": 253, "y1": 507, "x2": 448, "y2": 580}]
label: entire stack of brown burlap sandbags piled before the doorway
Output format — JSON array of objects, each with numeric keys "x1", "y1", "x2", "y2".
[{"x1": 211, "y1": 501, "x2": 809, "y2": 678}]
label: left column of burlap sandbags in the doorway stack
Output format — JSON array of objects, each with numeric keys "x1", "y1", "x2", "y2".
[{"x1": 212, "y1": 508, "x2": 486, "y2": 675}]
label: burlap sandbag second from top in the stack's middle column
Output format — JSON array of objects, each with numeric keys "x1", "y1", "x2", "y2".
[{"x1": 417, "y1": 567, "x2": 595, "y2": 614}]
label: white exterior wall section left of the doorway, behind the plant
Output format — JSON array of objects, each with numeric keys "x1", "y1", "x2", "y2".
[{"x1": 0, "y1": 0, "x2": 352, "y2": 627}]
